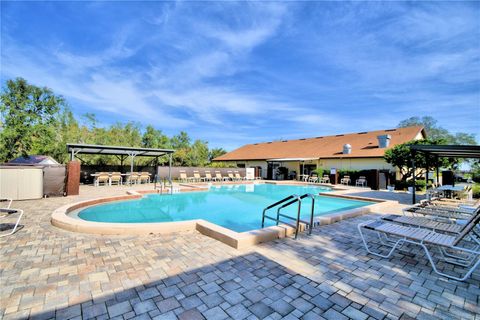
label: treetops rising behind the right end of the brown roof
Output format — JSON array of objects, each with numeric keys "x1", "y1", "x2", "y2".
[{"x1": 398, "y1": 116, "x2": 477, "y2": 145}]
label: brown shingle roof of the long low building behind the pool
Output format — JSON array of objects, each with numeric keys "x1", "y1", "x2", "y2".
[{"x1": 214, "y1": 127, "x2": 425, "y2": 161}]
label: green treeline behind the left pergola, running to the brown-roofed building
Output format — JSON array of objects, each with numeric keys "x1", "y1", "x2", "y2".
[{"x1": 0, "y1": 78, "x2": 226, "y2": 166}]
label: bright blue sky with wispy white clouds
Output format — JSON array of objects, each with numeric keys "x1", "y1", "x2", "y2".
[{"x1": 0, "y1": 1, "x2": 480, "y2": 150}]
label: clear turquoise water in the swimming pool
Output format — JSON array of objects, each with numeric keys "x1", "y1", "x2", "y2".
[{"x1": 78, "y1": 184, "x2": 371, "y2": 232}]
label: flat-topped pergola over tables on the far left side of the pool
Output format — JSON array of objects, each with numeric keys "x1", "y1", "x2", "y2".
[{"x1": 67, "y1": 143, "x2": 175, "y2": 180}]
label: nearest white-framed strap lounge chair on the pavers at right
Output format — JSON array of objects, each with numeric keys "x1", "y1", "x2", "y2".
[{"x1": 358, "y1": 211, "x2": 480, "y2": 281}]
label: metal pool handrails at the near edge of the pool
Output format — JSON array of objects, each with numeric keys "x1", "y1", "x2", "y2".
[{"x1": 262, "y1": 193, "x2": 315, "y2": 239}]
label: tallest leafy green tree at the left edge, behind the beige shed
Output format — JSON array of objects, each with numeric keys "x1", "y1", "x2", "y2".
[{"x1": 0, "y1": 78, "x2": 66, "y2": 161}]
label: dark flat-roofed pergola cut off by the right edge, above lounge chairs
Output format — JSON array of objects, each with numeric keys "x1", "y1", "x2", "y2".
[{"x1": 410, "y1": 144, "x2": 480, "y2": 203}]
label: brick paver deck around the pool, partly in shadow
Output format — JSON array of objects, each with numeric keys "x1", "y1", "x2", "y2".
[{"x1": 0, "y1": 187, "x2": 480, "y2": 319}]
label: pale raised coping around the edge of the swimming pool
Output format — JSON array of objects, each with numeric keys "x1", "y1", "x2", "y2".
[{"x1": 51, "y1": 184, "x2": 394, "y2": 249}]
